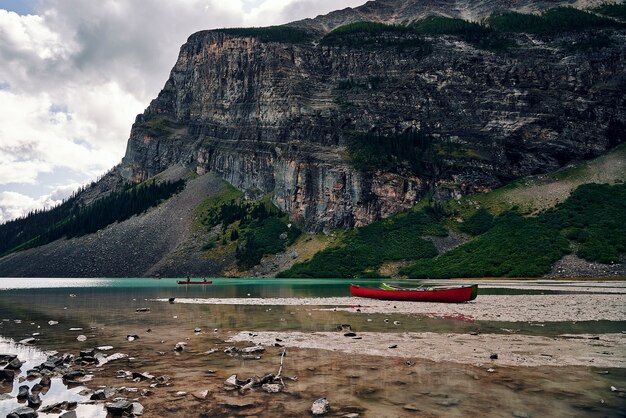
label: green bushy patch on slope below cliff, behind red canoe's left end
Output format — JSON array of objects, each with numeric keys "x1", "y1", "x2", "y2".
[{"x1": 278, "y1": 208, "x2": 447, "y2": 278}]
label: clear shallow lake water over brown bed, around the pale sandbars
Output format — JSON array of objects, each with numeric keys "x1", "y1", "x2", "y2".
[{"x1": 0, "y1": 279, "x2": 626, "y2": 417}]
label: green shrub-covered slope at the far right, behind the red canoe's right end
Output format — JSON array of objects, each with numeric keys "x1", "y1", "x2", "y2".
[{"x1": 401, "y1": 183, "x2": 626, "y2": 278}]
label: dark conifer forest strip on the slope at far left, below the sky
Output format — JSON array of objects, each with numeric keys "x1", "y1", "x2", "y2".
[{"x1": 0, "y1": 180, "x2": 185, "y2": 255}]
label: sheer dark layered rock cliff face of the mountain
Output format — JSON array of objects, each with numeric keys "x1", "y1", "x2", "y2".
[{"x1": 120, "y1": 0, "x2": 626, "y2": 231}]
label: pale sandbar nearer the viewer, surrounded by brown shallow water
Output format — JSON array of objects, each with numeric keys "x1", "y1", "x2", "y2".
[{"x1": 229, "y1": 332, "x2": 626, "y2": 367}]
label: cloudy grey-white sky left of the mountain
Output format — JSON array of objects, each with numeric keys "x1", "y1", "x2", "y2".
[{"x1": 0, "y1": 0, "x2": 365, "y2": 223}]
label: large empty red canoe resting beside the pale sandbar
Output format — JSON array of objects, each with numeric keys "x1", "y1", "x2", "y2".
[{"x1": 350, "y1": 284, "x2": 473, "y2": 303}]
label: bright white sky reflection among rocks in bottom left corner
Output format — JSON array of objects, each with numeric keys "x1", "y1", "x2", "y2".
[{"x1": 0, "y1": 336, "x2": 106, "y2": 418}]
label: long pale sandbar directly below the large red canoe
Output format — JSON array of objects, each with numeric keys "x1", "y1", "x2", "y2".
[{"x1": 160, "y1": 293, "x2": 626, "y2": 322}]
